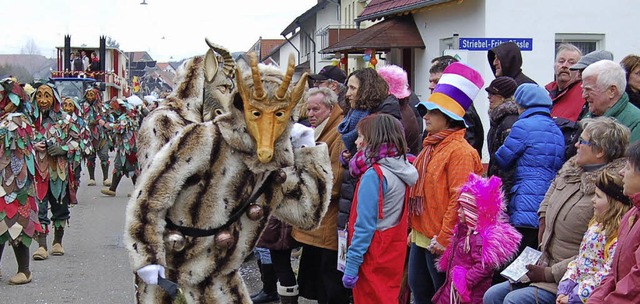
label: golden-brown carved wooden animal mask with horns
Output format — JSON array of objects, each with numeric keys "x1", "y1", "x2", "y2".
[{"x1": 236, "y1": 52, "x2": 307, "y2": 163}]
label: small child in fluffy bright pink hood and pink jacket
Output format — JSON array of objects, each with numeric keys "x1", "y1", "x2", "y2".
[{"x1": 432, "y1": 173, "x2": 522, "y2": 304}]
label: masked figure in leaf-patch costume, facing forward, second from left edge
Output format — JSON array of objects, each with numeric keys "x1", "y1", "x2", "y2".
[{"x1": 31, "y1": 83, "x2": 79, "y2": 260}]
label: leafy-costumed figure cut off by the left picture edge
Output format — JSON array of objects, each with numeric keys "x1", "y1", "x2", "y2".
[{"x1": 0, "y1": 78, "x2": 42, "y2": 284}]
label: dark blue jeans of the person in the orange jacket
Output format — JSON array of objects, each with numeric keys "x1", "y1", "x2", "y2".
[{"x1": 408, "y1": 243, "x2": 446, "y2": 304}]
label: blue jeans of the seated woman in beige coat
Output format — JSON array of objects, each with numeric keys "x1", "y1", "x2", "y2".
[{"x1": 482, "y1": 282, "x2": 556, "y2": 304}]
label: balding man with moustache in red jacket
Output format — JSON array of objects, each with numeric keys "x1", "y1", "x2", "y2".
[{"x1": 545, "y1": 43, "x2": 587, "y2": 121}]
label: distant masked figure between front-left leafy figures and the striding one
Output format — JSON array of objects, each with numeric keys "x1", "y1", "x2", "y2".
[{"x1": 82, "y1": 88, "x2": 111, "y2": 186}]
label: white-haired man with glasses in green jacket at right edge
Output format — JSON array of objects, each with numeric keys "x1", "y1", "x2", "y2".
[{"x1": 582, "y1": 60, "x2": 640, "y2": 143}]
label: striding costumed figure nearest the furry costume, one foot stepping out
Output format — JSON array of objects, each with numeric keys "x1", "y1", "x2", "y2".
[{"x1": 100, "y1": 97, "x2": 140, "y2": 196}]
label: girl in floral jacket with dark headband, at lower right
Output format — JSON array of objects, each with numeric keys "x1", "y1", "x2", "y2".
[{"x1": 556, "y1": 171, "x2": 631, "y2": 304}]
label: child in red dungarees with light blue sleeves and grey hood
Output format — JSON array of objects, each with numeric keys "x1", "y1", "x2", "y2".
[{"x1": 342, "y1": 114, "x2": 418, "y2": 303}]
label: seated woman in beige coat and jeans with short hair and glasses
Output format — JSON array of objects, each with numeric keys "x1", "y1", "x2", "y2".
[{"x1": 484, "y1": 117, "x2": 629, "y2": 303}]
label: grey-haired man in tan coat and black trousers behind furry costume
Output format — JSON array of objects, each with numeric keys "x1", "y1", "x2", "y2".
[{"x1": 292, "y1": 87, "x2": 349, "y2": 304}]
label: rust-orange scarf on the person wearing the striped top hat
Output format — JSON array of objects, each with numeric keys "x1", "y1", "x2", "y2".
[{"x1": 409, "y1": 129, "x2": 458, "y2": 215}]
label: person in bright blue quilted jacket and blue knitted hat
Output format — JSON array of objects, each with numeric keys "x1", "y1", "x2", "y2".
[{"x1": 495, "y1": 83, "x2": 565, "y2": 252}]
